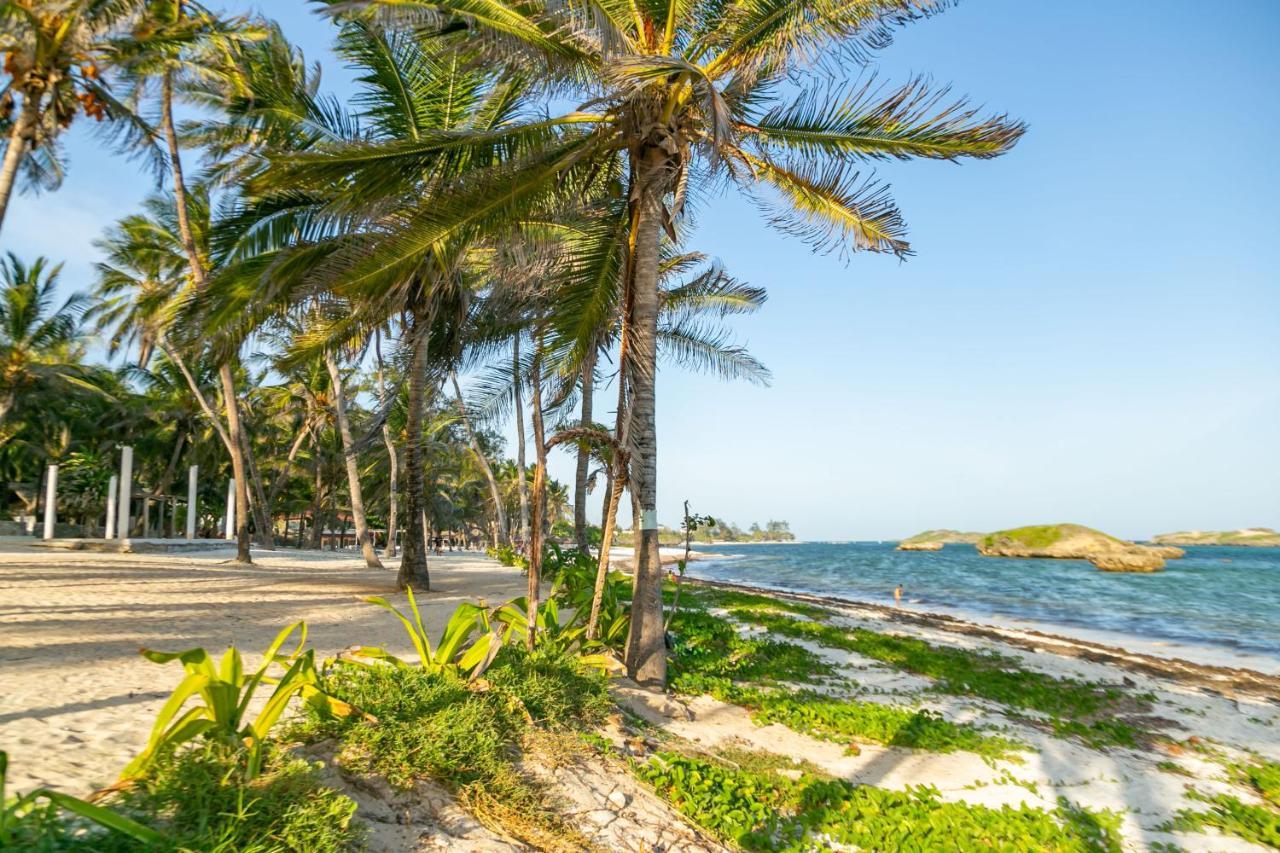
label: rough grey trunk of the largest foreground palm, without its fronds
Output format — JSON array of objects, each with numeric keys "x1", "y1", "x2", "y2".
[{"x1": 626, "y1": 146, "x2": 671, "y2": 685}]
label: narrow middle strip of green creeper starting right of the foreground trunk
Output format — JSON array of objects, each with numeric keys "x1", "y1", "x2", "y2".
[{"x1": 677, "y1": 679, "x2": 1024, "y2": 758}]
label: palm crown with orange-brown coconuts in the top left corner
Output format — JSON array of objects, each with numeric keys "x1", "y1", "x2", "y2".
[{"x1": 0, "y1": 0, "x2": 150, "y2": 228}]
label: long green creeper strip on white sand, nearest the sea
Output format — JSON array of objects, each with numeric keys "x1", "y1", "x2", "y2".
[{"x1": 731, "y1": 610, "x2": 1152, "y2": 747}]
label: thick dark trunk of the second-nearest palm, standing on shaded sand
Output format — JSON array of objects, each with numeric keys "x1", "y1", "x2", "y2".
[{"x1": 396, "y1": 306, "x2": 431, "y2": 589}]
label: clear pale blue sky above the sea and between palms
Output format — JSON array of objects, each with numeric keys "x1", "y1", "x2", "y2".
[{"x1": 0, "y1": 0, "x2": 1280, "y2": 539}]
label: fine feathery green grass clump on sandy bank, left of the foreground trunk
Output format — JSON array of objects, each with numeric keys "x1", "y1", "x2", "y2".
[{"x1": 294, "y1": 647, "x2": 611, "y2": 848}]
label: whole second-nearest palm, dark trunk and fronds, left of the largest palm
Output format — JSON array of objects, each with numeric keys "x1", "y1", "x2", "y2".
[{"x1": 210, "y1": 23, "x2": 547, "y2": 588}]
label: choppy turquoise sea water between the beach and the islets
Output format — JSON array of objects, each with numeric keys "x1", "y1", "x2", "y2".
[{"x1": 689, "y1": 542, "x2": 1280, "y2": 662}]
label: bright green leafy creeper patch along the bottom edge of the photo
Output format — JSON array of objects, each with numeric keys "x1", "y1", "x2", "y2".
[{"x1": 637, "y1": 752, "x2": 1120, "y2": 853}]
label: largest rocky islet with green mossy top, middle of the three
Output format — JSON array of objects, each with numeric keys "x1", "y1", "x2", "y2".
[{"x1": 977, "y1": 524, "x2": 1184, "y2": 573}]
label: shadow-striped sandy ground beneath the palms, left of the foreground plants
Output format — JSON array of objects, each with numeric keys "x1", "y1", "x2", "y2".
[{"x1": 0, "y1": 542, "x2": 525, "y2": 794}]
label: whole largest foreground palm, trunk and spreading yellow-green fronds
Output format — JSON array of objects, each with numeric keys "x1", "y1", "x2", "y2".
[{"x1": 327, "y1": 0, "x2": 1024, "y2": 683}]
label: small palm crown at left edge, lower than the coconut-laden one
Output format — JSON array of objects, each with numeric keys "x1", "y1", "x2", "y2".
[{"x1": 0, "y1": 252, "x2": 96, "y2": 428}]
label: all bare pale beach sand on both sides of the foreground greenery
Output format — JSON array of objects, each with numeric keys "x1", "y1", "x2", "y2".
[{"x1": 0, "y1": 543, "x2": 1280, "y2": 850}]
